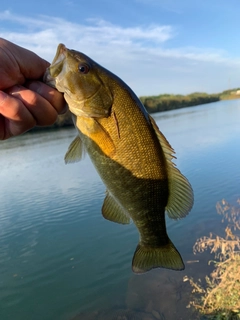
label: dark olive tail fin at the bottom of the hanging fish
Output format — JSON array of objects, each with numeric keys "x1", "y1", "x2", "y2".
[{"x1": 132, "y1": 239, "x2": 185, "y2": 273}]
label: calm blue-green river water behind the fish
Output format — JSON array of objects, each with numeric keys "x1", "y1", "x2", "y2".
[{"x1": 0, "y1": 100, "x2": 240, "y2": 320}]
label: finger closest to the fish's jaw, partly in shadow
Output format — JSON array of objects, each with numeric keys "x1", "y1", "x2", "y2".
[{"x1": 25, "y1": 81, "x2": 67, "y2": 114}]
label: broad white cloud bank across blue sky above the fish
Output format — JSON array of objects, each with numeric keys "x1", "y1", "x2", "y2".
[{"x1": 0, "y1": 11, "x2": 240, "y2": 95}]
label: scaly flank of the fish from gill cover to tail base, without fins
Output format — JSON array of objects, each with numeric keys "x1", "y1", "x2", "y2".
[{"x1": 74, "y1": 84, "x2": 168, "y2": 247}]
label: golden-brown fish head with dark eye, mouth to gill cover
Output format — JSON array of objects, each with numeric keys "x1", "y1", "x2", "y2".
[{"x1": 44, "y1": 44, "x2": 113, "y2": 118}]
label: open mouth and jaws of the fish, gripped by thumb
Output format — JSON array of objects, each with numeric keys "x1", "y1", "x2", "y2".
[{"x1": 43, "y1": 43, "x2": 67, "y2": 88}]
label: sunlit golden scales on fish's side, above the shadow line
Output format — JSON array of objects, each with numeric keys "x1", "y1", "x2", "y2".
[{"x1": 98, "y1": 92, "x2": 167, "y2": 179}]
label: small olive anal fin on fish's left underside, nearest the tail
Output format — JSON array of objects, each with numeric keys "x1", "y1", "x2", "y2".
[{"x1": 102, "y1": 191, "x2": 130, "y2": 224}]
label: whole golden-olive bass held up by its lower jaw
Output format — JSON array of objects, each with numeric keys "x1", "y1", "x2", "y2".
[{"x1": 44, "y1": 44, "x2": 193, "y2": 274}]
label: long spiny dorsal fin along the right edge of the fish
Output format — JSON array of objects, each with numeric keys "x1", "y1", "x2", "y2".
[{"x1": 149, "y1": 116, "x2": 193, "y2": 219}]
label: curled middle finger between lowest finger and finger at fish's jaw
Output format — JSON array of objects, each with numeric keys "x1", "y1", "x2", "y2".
[{"x1": 8, "y1": 86, "x2": 58, "y2": 126}]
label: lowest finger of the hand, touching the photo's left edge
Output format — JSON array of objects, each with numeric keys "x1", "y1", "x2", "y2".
[{"x1": 0, "y1": 91, "x2": 36, "y2": 140}]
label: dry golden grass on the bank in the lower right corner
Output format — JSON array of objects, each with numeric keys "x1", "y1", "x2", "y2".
[{"x1": 184, "y1": 200, "x2": 240, "y2": 320}]
